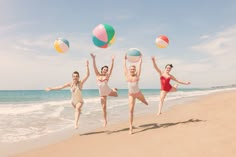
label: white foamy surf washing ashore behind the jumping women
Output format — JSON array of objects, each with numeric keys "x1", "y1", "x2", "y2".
[{"x1": 0, "y1": 88, "x2": 235, "y2": 143}]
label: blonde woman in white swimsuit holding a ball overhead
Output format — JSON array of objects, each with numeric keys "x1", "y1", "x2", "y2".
[{"x1": 124, "y1": 56, "x2": 148, "y2": 134}]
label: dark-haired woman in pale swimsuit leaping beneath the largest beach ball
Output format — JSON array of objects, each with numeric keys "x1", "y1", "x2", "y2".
[{"x1": 90, "y1": 53, "x2": 118, "y2": 127}]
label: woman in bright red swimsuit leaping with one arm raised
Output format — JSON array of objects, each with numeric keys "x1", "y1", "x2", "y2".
[{"x1": 152, "y1": 57, "x2": 190, "y2": 115}]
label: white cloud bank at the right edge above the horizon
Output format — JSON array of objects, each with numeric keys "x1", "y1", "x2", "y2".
[{"x1": 189, "y1": 26, "x2": 236, "y2": 86}]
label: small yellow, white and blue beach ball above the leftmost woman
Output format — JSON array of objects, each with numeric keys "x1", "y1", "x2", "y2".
[{"x1": 54, "y1": 38, "x2": 70, "y2": 53}]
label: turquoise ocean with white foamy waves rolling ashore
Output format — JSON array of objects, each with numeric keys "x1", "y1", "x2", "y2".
[{"x1": 0, "y1": 88, "x2": 235, "y2": 144}]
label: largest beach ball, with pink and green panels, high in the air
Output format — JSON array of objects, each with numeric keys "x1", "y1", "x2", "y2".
[{"x1": 93, "y1": 24, "x2": 115, "y2": 48}]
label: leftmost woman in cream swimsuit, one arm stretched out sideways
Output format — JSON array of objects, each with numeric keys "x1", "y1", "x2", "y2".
[{"x1": 46, "y1": 61, "x2": 90, "y2": 129}]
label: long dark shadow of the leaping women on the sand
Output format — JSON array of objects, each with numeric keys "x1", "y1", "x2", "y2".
[{"x1": 81, "y1": 119, "x2": 206, "y2": 135}]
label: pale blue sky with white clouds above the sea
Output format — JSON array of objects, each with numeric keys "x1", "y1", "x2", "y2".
[{"x1": 0, "y1": 0, "x2": 236, "y2": 90}]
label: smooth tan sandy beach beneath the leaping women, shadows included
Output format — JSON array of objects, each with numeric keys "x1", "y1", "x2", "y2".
[{"x1": 13, "y1": 90, "x2": 236, "y2": 157}]
